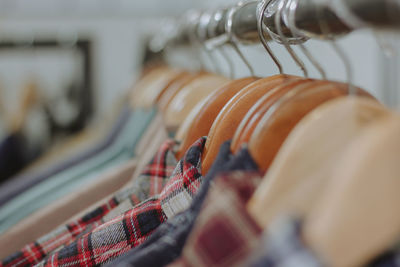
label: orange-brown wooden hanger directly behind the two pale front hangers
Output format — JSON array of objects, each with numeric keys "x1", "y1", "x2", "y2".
[{"x1": 248, "y1": 83, "x2": 370, "y2": 172}]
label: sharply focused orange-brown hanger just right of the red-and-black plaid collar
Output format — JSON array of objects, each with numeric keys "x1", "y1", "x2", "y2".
[{"x1": 202, "y1": 75, "x2": 301, "y2": 174}]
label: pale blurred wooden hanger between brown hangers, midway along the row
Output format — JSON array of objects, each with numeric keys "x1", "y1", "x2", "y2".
[{"x1": 164, "y1": 74, "x2": 229, "y2": 131}]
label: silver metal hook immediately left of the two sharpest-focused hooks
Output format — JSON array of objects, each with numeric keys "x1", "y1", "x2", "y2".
[{"x1": 225, "y1": 1, "x2": 255, "y2": 76}]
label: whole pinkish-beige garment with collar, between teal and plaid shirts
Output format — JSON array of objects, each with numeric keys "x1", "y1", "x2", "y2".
[{"x1": 0, "y1": 110, "x2": 167, "y2": 259}]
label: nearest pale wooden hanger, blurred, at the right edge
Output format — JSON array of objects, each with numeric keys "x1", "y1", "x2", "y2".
[{"x1": 303, "y1": 115, "x2": 400, "y2": 267}]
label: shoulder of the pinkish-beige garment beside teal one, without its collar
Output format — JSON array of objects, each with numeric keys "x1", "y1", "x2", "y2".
[{"x1": 0, "y1": 160, "x2": 136, "y2": 259}]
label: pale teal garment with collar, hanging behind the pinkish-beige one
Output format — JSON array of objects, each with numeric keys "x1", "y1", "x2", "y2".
[{"x1": 0, "y1": 109, "x2": 155, "y2": 232}]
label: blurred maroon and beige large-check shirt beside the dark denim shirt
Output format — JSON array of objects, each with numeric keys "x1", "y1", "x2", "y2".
[{"x1": 171, "y1": 171, "x2": 262, "y2": 266}]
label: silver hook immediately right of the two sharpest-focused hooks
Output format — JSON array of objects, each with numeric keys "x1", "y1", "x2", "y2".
[{"x1": 283, "y1": 0, "x2": 327, "y2": 80}]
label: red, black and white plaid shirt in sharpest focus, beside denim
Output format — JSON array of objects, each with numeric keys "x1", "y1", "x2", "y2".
[{"x1": 33, "y1": 138, "x2": 205, "y2": 266}]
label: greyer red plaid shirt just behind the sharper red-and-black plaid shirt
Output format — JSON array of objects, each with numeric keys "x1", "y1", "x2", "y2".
[{"x1": 0, "y1": 140, "x2": 177, "y2": 266}]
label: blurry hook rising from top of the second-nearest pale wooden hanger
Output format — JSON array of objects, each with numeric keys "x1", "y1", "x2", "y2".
[{"x1": 317, "y1": 2, "x2": 356, "y2": 95}]
